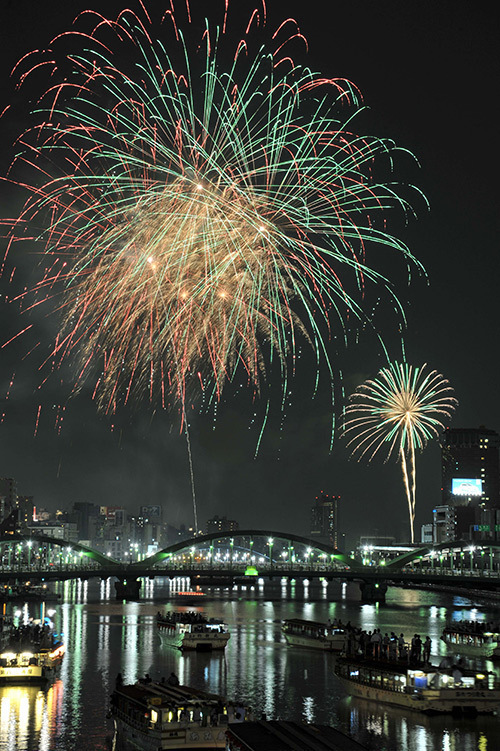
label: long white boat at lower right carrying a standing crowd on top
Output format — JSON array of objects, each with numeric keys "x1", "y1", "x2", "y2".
[{"x1": 334, "y1": 656, "x2": 500, "y2": 715}]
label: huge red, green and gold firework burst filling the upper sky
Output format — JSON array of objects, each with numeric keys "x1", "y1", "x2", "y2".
[{"x1": 3, "y1": 2, "x2": 426, "y2": 434}]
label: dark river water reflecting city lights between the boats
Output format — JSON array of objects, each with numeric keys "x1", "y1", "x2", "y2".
[{"x1": 0, "y1": 579, "x2": 500, "y2": 751}]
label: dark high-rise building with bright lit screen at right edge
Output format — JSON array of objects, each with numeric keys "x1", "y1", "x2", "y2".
[{"x1": 441, "y1": 425, "x2": 500, "y2": 508}]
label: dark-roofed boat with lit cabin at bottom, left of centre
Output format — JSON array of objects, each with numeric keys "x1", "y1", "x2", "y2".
[{"x1": 110, "y1": 679, "x2": 252, "y2": 751}]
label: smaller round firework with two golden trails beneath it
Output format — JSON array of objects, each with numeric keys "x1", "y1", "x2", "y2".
[{"x1": 343, "y1": 362, "x2": 457, "y2": 542}]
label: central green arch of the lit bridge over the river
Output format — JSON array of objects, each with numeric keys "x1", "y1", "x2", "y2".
[{"x1": 130, "y1": 529, "x2": 362, "y2": 570}]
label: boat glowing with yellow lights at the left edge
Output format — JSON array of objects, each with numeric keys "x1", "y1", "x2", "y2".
[{"x1": 0, "y1": 621, "x2": 66, "y2": 684}]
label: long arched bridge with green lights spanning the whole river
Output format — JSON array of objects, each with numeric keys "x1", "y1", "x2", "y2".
[{"x1": 0, "y1": 529, "x2": 500, "y2": 599}]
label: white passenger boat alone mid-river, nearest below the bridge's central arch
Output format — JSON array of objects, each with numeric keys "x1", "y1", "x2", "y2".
[{"x1": 156, "y1": 611, "x2": 231, "y2": 651}]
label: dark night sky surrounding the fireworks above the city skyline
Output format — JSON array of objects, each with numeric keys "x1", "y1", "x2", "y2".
[{"x1": 0, "y1": 0, "x2": 500, "y2": 542}]
